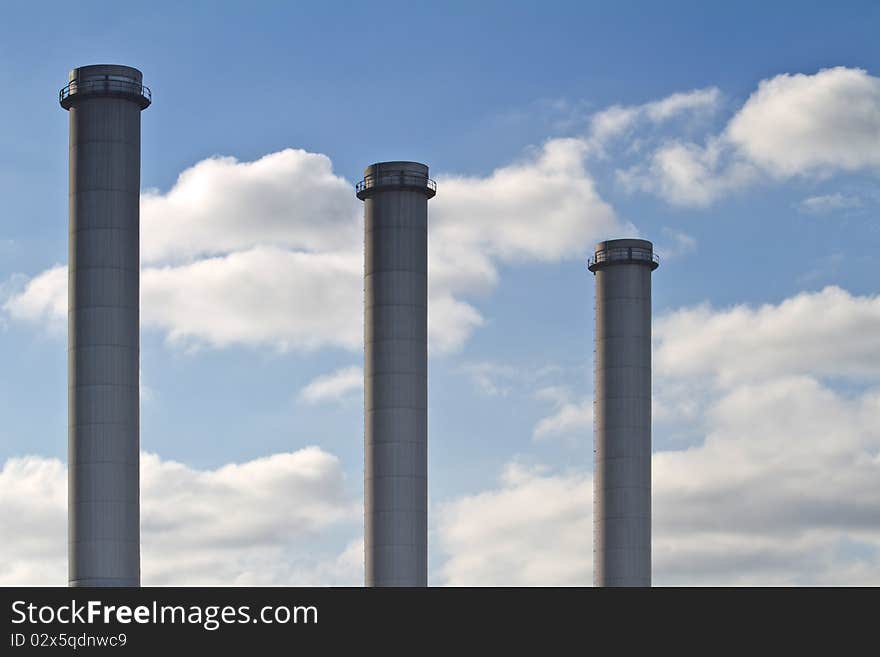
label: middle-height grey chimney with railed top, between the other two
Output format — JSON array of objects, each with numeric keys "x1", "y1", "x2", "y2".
[{"x1": 357, "y1": 162, "x2": 436, "y2": 586}]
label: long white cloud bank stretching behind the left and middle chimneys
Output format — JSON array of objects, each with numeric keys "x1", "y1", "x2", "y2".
[{"x1": 3, "y1": 139, "x2": 634, "y2": 353}]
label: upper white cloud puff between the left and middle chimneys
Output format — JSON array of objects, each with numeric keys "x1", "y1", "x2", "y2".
[{"x1": 141, "y1": 148, "x2": 363, "y2": 263}]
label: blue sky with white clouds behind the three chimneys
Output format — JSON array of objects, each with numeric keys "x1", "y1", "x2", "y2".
[{"x1": 0, "y1": 2, "x2": 880, "y2": 585}]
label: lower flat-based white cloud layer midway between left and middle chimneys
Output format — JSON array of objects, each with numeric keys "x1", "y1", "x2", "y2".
[{"x1": 141, "y1": 247, "x2": 363, "y2": 350}]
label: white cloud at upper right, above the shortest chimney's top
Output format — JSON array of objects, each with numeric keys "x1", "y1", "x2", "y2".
[{"x1": 618, "y1": 67, "x2": 880, "y2": 206}]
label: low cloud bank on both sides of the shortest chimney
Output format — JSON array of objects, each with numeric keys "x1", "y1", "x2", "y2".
[{"x1": 438, "y1": 288, "x2": 880, "y2": 585}]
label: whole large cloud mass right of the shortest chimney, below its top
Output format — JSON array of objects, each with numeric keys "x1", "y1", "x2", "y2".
[{"x1": 654, "y1": 287, "x2": 880, "y2": 584}]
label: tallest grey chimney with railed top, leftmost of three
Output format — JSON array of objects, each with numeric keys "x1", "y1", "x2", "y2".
[{"x1": 60, "y1": 65, "x2": 150, "y2": 586}]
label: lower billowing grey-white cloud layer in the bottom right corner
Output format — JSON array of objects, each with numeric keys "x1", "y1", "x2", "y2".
[{"x1": 654, "y1": 376, "x2": 880, "y2": 584}]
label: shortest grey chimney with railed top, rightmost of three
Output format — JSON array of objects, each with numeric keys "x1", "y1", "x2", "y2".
[{"x1": 589, "y1": 239, "x2": 660, "y2": 586}]
